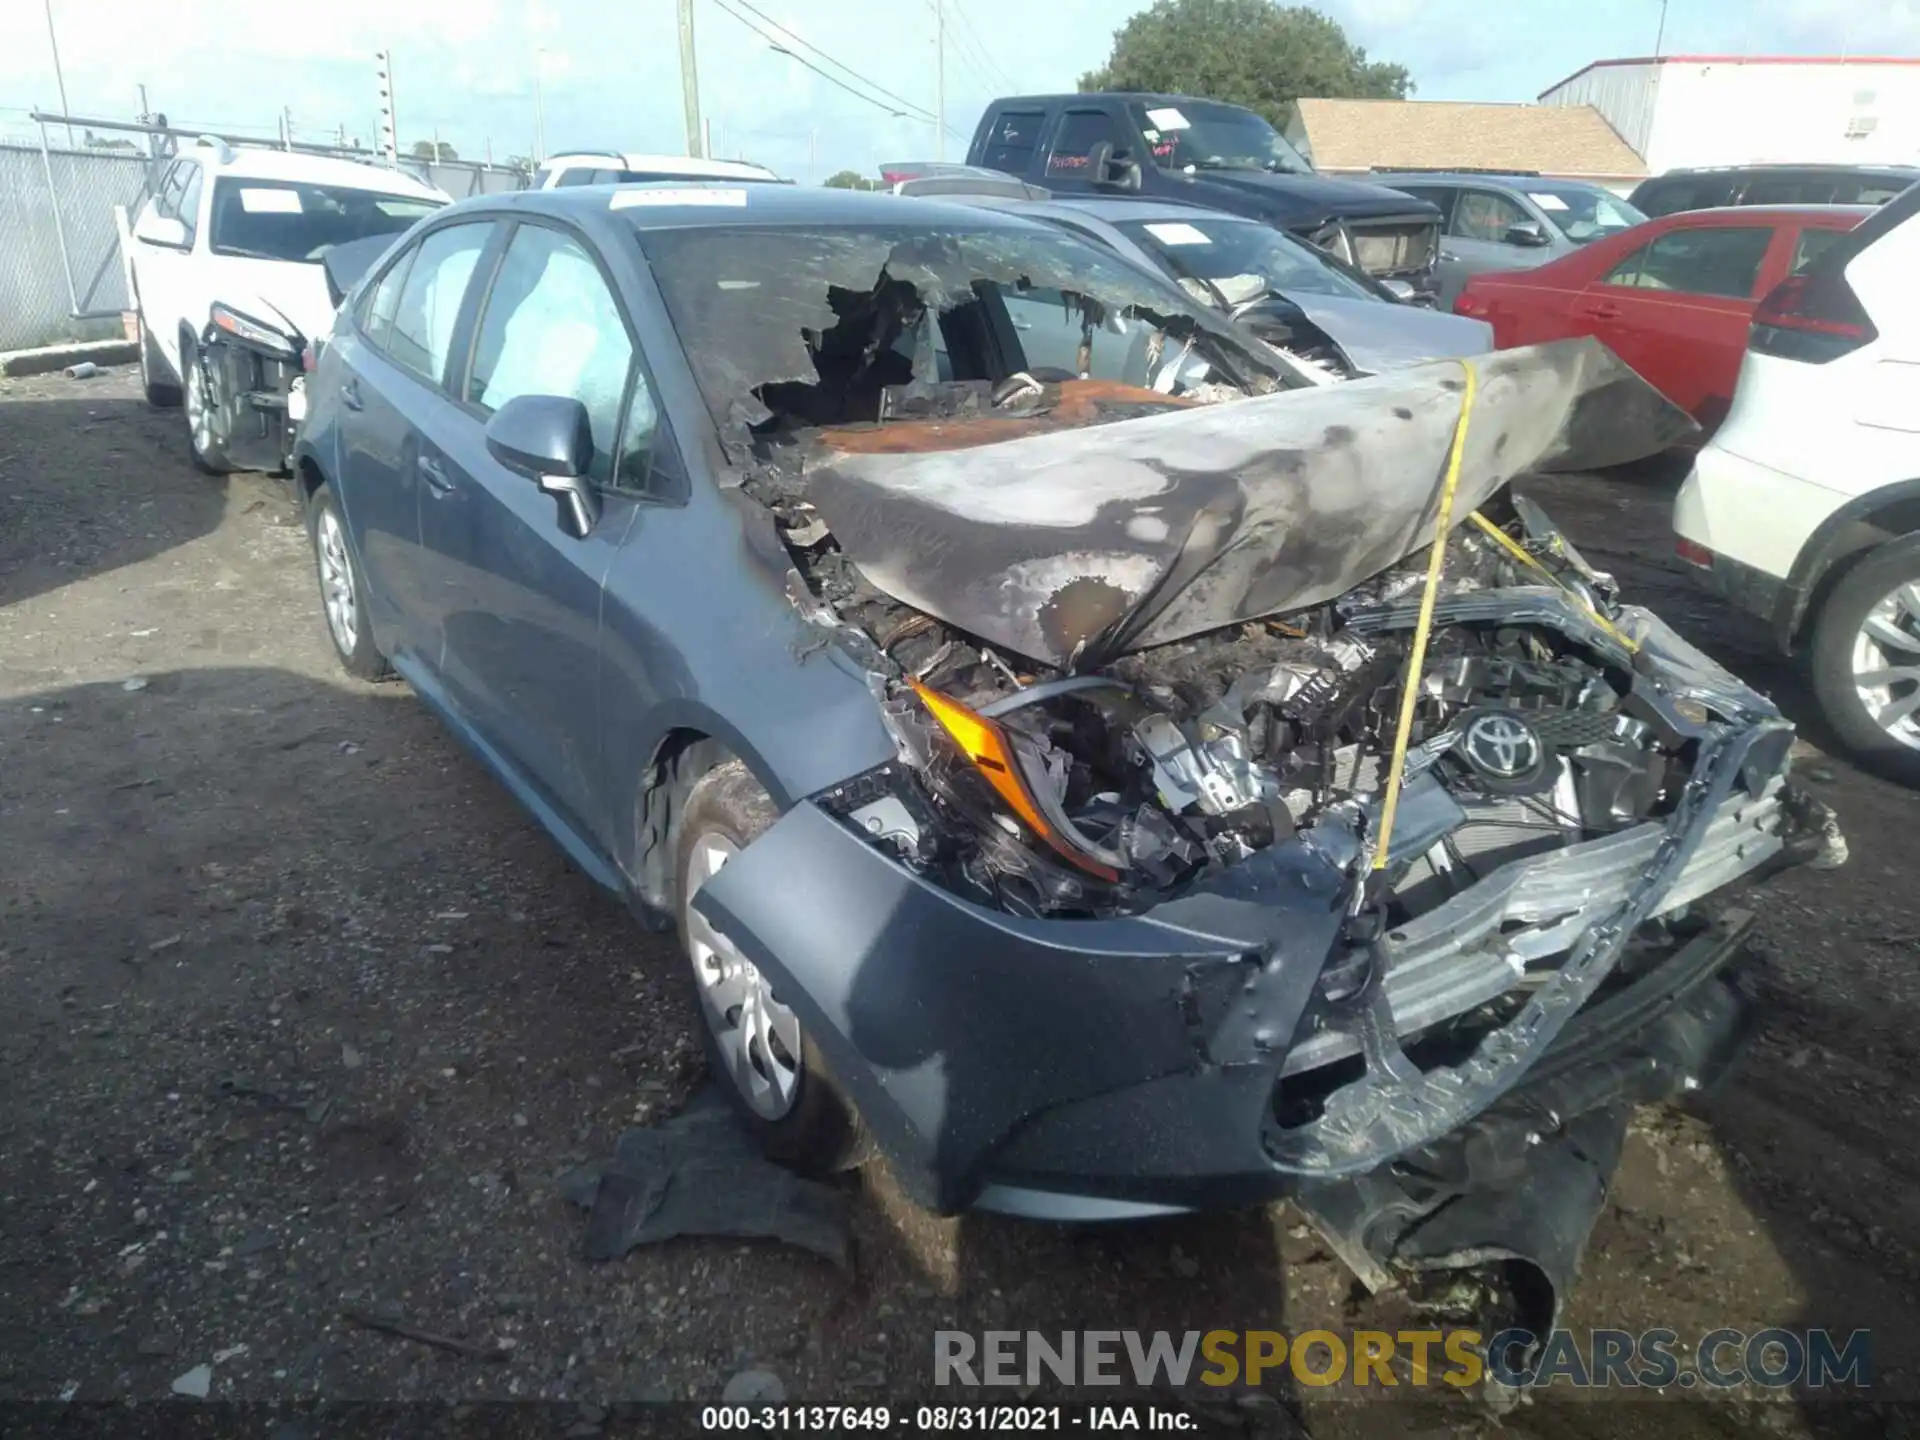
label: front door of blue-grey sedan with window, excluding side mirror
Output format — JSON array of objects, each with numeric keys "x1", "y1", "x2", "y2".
[{"x1": 420, "y1": 223, "x2": 636, "y2": 839}]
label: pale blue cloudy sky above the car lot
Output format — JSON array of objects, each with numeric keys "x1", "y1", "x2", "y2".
[{"x1": 0, "y1": 0, "x2": 1920, "y2": 180}]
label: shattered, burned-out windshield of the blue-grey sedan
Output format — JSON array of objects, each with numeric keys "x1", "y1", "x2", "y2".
[{"x1": 641, "y1": 225, "x2": 1275, "y2": 436}]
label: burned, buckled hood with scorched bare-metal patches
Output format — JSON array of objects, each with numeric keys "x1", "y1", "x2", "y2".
[{"x1": 806, "y1": 340, "x2": 1695, "y2": 668}]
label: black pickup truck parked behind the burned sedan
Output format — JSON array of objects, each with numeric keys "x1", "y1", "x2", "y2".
[{"x1": 968, "y1": 90, "x2": 1440, "y2": 300}]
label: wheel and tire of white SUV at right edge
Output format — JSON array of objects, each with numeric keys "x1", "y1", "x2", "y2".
[{"x1": 1812, "y1": 534, "x2": 1920, "y2": 785}]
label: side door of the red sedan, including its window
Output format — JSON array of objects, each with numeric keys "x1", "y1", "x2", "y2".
[{"x1": 1572, "y1": 223, "x2": 1784, "y2": 428}]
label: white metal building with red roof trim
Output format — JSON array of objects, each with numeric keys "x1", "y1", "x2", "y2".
[{"x1": 1540, "y1": 56, "x2": 1920, "y2": 175}]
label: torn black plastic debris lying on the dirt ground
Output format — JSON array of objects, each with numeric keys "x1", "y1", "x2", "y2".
[{"x1": 559, "y1": 1091, "x2": 851, "y2": 1265}]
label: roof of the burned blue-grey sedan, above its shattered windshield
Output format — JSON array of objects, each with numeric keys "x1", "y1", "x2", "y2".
[{"x1": 461, "y1": 180, "x2": 1033, "y2": 230}]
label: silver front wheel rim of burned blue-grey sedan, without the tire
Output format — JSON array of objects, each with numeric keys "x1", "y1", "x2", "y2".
[{"x1": 685, "y1": 833, "x2": 801, "y2": 1119}]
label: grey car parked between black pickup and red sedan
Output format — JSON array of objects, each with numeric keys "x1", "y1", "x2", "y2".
[{"x1": 1375, "y1": 171, "x2": 1645, "y2": 305}]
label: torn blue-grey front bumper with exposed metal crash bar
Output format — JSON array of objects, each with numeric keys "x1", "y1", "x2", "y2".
[{"x1": 695, "y1": 612, "x2": 1832, "y2": 1217}]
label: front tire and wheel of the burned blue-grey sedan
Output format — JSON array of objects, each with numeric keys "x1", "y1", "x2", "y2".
[{"x1": 674, "y1": 760, "x2": 862, "y2": 1175}]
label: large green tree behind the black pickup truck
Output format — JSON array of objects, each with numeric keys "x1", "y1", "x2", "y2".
[{"x1": 1079, "y1": 0, "x2": 1413, "y2": 127}]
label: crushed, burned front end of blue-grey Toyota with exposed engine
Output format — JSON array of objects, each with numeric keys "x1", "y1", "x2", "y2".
[{"x1": 668, "y1": 222, "x2": 1843, "y2": 1323}]
